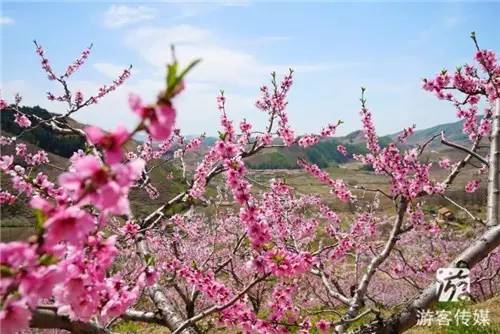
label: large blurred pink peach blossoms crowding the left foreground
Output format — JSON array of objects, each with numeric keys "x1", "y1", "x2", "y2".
[{"x1": 0, "y1": 40, "x2": 186, "y2": 333}]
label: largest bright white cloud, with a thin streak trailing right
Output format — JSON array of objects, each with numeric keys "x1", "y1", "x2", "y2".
[{"x1": 125, "y1": 24, "x2": 340, "y2": 88}]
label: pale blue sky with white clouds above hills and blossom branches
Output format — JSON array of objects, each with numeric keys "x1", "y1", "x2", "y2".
[{"x1": 0, "y1": 2, "x2": 500, "y2": 135}]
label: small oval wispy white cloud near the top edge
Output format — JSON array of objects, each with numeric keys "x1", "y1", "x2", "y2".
[{"x1": 103, "y1": 5, "x2": 157, "y2": 28}]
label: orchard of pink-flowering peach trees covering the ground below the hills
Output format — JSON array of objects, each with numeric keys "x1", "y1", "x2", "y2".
[{"x1": 0, "y1": 34, "x2": 500, "y2": 334}]
